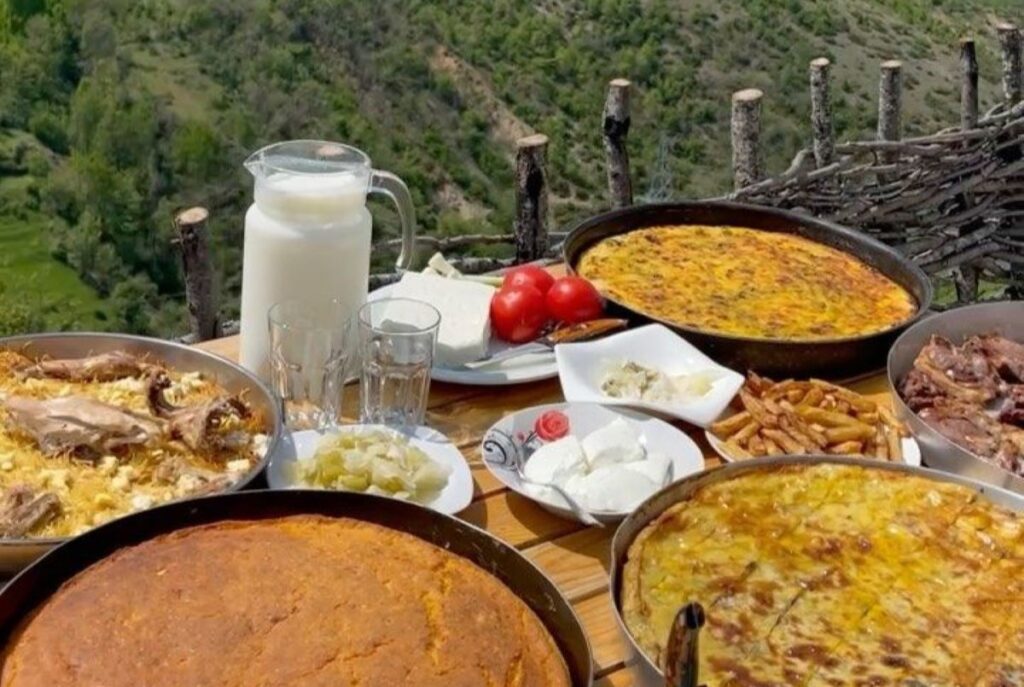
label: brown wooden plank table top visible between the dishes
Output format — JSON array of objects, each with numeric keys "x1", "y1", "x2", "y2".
[{"x1": 193, "y1": 337, "x2": 891, "y2": 687}]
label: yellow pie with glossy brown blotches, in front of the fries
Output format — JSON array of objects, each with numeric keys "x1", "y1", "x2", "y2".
[{"x1": 622, "y1": 464, "x2": 1024, "y2": 687}]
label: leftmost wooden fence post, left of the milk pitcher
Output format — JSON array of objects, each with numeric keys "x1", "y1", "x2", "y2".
[{"x1": 174, "y1": 208, "x2": 220, "y2": 342}]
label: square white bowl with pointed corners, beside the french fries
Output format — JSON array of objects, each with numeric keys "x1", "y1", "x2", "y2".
[{"x1": 555, "y1": 325, "x2": 743, "y2": 427}]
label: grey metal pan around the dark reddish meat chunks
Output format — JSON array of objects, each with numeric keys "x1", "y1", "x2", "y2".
[{"x1": 889, "y1": 301, "x2": 1024, "y2": 493}]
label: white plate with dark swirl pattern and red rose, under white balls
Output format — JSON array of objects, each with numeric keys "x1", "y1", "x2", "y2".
[{"x1": 480, "y1": 403, "x2": 703, "y2": 523}]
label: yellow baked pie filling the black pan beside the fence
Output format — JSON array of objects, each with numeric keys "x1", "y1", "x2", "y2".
[{"x1": 578, "y1": 226, "x2": 916, "y2": 341}]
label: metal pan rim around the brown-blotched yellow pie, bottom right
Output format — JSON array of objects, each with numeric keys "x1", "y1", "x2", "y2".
[{"x1": 610, "y1": 456, "x2": 1024, "y2": 687}]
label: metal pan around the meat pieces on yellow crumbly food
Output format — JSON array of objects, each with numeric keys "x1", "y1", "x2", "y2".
[{"x1": 0, "y1": 334, "x2": 281, "y2": 574}]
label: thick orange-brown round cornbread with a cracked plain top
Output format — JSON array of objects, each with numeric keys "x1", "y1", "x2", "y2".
[{"x1": 0, "y1": 516, "x2": 569, "y2": 687}]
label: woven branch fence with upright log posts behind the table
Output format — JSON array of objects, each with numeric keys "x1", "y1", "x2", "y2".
[{"x1": 175, "y1": 24, "x2": 1024, "y2": 341}]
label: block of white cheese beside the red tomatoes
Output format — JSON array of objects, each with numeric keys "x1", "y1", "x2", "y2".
[{"x1": 389, "y1": 272, "x2": 495, "y2": 368}]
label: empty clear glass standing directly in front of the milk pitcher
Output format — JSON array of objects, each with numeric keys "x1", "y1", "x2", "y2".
[{"x1": 267, "y1": 299, "x2": 352, "y2": 429}]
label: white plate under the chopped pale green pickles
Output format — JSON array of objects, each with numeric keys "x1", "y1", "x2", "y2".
[{"x1": 266, "y1": 425, "x2": 473, "y2": 515}]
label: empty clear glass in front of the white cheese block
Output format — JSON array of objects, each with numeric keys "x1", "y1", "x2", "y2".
[{"x1": 358, "y1": 298, "x2": 441, "y2": 428}]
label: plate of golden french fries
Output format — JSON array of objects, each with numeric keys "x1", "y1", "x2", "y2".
[{"x1": 707, "y1": 373, "x2": 921, "y2": 465}]
